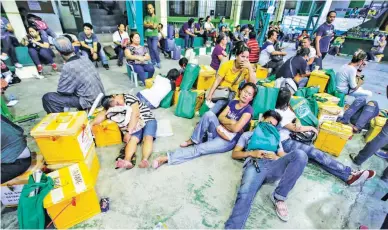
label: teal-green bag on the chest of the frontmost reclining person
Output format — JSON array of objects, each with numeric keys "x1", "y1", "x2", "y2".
[{"x1": 247, "y1": 122, "x2": 280, "y2": 152}]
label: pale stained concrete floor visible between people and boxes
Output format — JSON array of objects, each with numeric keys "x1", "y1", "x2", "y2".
[{"x1": 1, "y1": 44, "x2": 388, "y2": 229}]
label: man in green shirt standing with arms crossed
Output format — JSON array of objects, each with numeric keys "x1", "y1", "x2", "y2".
[{"x1": 144, "y1": 4, "x2": 161, "y2": 69}]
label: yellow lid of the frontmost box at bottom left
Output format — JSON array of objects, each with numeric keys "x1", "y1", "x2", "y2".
[{"x1": 43, "y1": 162, "x2": 93, "y2": 208}]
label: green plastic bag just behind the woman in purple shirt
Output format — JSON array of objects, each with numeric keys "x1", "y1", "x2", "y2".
[{"x1": 253, "y1": 86, "x2": 279, "y2": 120}]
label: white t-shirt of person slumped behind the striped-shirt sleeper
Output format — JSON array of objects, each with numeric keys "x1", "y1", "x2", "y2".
[{"x1": 140, "y1": 75, "x2": 171, "y2": 108}]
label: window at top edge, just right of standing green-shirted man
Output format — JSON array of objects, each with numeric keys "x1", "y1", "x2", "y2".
[{"x1": 168, "y1": 0, "x2": 198, "y2": 17}]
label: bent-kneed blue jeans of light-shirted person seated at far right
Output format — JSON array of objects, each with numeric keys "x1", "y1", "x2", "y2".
[{"x1": 338, "y1": 97, "x2": 380, "y2": 130}]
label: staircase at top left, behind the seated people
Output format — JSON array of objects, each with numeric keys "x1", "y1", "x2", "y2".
[{"x1": 89, "y1": 1, "x2": 125, "y2": 34}]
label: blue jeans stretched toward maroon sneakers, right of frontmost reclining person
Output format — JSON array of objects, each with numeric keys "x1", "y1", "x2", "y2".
[{"x1": 282, "y1": 138, "x2": 352, "y2": 182}]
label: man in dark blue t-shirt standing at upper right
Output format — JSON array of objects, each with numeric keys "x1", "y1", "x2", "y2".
[{"x1": 315, "y1": 11, "x2": 337, "y2": 69}]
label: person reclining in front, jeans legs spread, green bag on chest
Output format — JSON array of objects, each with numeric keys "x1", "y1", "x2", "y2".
[{"x1": 225, "y1": 110, "x2": 308, "y2": 229}]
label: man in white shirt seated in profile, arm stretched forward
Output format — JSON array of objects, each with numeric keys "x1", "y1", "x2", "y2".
[{"x1": 259, "y1": 30, "x2": 287, "y2": 73}]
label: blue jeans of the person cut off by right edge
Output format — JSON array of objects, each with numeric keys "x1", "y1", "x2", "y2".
[{"x1": 354, "y1": 122, "x2": 388, "y2": 180}]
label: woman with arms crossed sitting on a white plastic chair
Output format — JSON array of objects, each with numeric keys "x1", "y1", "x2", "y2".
[{"x1": 125, "y1": 32, "x2": 155, "y2": 84}]
